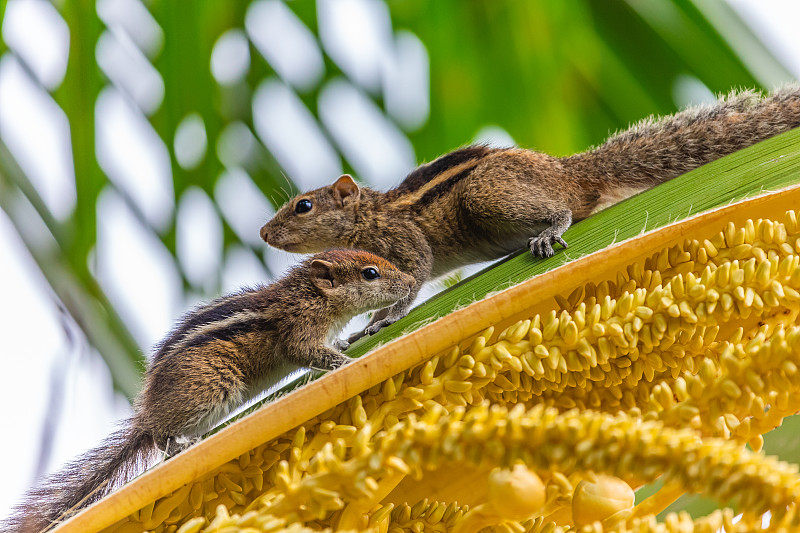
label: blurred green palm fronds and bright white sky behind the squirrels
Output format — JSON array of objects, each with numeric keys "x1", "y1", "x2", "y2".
[{"x1": 0, "y1": 0, "x2": 800, "y2": 516}]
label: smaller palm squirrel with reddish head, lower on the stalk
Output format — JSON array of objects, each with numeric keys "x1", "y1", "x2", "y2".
[{"x1": 7, "y1": 250, "x2": 415, "y2": 532}]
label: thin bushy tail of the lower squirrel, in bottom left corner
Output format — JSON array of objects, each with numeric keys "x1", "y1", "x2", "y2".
[{"x1": 5, "y1": 421, "x2": 155, "y2": 533}]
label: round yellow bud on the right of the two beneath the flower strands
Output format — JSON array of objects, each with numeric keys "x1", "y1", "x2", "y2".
[{"x1": 572, "y1": 476, "x2": 634, "y2": 527}]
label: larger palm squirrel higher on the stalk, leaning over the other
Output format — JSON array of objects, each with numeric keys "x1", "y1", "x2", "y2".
[{"x1": 261, "y1": 87, "x2": 800, "y2": 342}]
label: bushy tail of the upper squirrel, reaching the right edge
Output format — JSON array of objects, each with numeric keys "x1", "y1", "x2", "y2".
[{"x1": 564, "y1": 85, "x2": 800, "y2": 187}]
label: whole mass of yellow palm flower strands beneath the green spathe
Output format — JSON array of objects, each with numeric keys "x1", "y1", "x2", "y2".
[{"x1": 106, "y1": 211, "x2": 800, "y2": 533}]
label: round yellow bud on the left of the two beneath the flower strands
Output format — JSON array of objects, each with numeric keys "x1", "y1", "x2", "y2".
[{"x1": 489, "y1": 464, "x2": 545, "y2": 520}]
